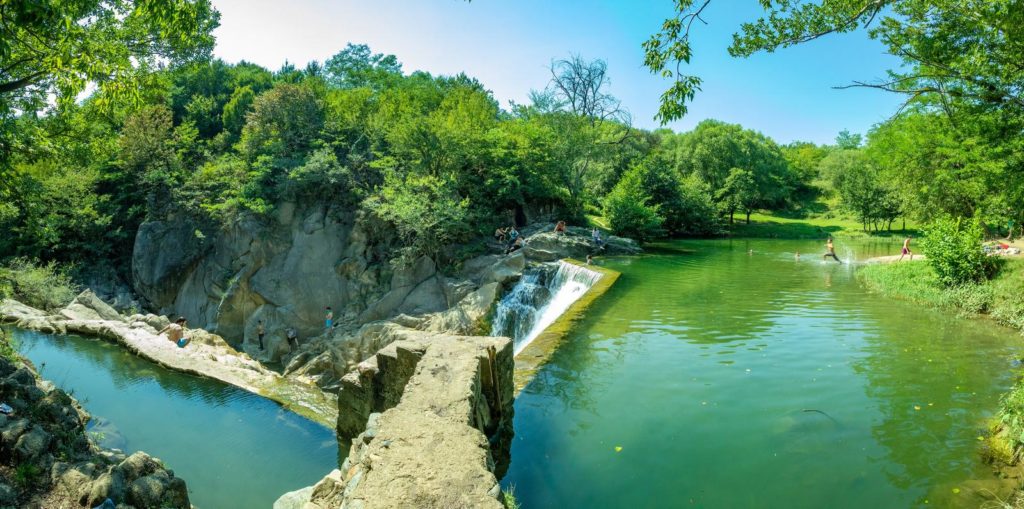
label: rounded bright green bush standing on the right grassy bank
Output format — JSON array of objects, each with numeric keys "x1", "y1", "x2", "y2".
[{"x1": 922, "y1": 217, "x2": 999, "y2": 287}]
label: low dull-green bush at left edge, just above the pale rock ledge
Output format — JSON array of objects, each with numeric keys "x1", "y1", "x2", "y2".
[{"x1": 0, "y1": 258, "x2": 78, "y2": 310}]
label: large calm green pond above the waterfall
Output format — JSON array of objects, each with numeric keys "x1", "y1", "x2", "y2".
[{"x1": 503, "y1": 241, "x2": 1022, "y2": 509}]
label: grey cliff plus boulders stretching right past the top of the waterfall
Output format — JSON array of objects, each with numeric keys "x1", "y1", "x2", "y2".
[{"x1": 132, "y1": 203, "x2": 639, "y2": 391}]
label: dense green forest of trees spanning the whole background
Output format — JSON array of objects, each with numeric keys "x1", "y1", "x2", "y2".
[{"x1": 0, "y1": 0, "x2": 1024, "y2": 282}]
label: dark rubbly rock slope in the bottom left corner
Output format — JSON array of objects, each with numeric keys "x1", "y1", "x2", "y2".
[{"x1": 0, "y1": 331, "x2": 191, "y2": 509}]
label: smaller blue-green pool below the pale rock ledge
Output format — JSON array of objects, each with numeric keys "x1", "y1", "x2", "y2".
[{"x1": 10, "y1": 329, "x2": 338, "y2": 509}]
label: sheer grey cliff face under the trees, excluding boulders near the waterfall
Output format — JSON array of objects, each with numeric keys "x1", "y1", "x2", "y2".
[{"x1": 132, "y1": 203, "x2": 407, "y2": 342}]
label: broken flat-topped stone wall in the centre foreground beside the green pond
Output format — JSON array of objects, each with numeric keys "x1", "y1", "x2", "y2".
[{"x1": 274, "y1": 330, "x2": 514, "y2": 509}]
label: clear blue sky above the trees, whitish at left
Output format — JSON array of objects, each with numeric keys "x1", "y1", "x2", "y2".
[{"x1": 213, "y1": 0, "x2": 901, "y2": 143}]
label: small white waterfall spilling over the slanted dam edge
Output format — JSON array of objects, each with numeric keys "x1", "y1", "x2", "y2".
[{"x1": 490, "y1": 261, "x2": 601, "y2": 354}]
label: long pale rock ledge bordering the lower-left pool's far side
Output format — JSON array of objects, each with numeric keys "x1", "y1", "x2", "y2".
[{"x1": 0, "y1": 290, "x2": 337, "y2": 425}]
